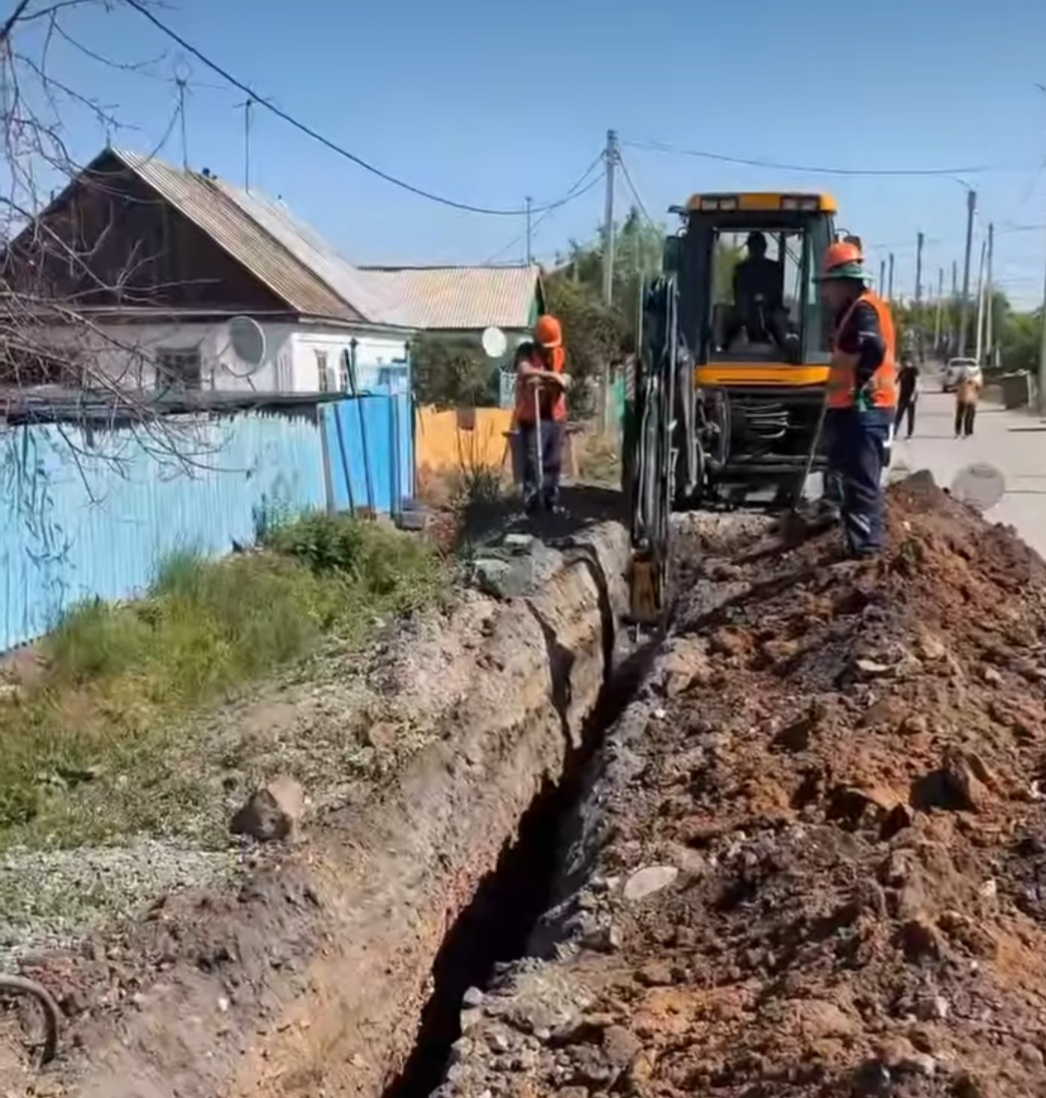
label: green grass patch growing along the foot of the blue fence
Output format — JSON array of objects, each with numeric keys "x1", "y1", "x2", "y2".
[{"x1": 0, "y1": 515, "x2": 447, "y2": 847}]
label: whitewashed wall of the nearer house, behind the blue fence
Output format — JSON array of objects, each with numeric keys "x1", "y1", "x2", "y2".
[{"x1": 33, "y1": 320, "x2": 407, "y2": 393}]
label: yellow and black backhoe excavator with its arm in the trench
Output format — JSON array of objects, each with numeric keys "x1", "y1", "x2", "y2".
[{"x1": 622, "y1": 192, "x2": 842, "y2": 626}]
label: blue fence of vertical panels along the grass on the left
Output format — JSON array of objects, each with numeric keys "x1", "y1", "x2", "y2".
[{"x1": 0, "y1": 392, "x2": 414, "y2": 650}]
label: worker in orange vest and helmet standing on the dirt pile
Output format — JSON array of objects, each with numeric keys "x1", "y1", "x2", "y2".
[{"x1": 818, "y1": 240, "x2": 897, "y2": 557}]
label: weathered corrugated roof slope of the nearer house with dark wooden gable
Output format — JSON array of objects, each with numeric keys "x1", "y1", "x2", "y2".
[{"x1": 112, "y1": 149, "x2": 403, "y2": 326}]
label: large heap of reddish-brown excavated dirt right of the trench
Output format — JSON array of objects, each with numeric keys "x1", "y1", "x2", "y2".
[{"x1": 443, "y1": 474, "x2": 1046, "y2": 1098}]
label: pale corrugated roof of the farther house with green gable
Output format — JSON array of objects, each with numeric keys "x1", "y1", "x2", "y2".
[{"x1": 362, "y1": 266, "x2": 539, "y2": 330}]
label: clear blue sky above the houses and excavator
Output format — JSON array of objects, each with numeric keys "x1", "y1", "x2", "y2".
[{"x1": 24, "y1": 0, "x2": 1046, "y2": 303}]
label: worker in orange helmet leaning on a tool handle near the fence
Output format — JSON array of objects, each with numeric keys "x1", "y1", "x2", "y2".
[{"x1": 515, "y1": 315, "x2": 571, "y2": 511}]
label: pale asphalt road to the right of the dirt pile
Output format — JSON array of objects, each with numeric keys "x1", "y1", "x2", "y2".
[{"x1": 891, "y1": 373, "x2": 1046, "y2": 557}]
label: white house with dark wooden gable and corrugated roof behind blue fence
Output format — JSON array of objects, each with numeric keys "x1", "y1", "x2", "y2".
[{"x1": 2, "y1": 148, "x2": 417, "y2": 392}]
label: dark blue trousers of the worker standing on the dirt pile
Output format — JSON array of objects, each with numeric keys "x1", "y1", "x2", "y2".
[{"x1": 825, "y1": 407, "x2": 895, "y2": 557}]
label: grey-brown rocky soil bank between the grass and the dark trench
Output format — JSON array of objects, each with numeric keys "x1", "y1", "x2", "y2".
[{"x1": 0, "y1": 524, "x2": 626, "y2": 1098}]
